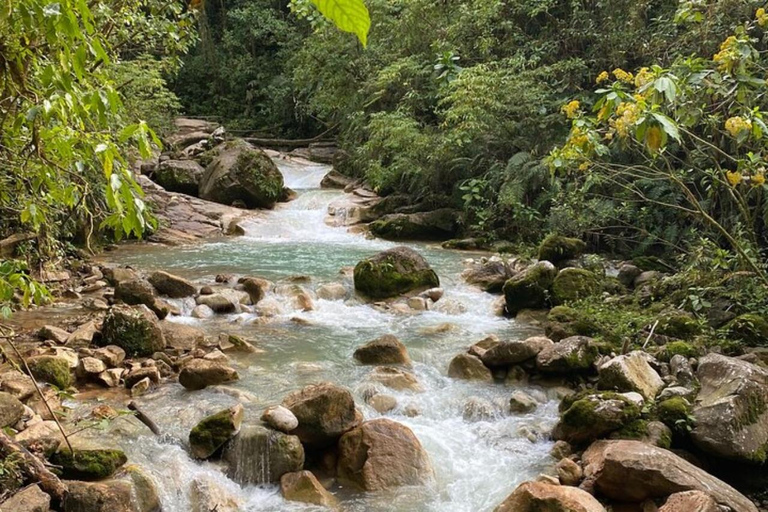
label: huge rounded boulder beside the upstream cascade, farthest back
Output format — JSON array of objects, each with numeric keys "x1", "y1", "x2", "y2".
[{"x1": 200, "y1": 141, "x2": 283, "y2": 208}]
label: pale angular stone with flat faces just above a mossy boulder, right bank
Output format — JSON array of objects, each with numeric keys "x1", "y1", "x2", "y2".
[{"x1": 598, "y1": 351, "x2": 664, "y2": 400}]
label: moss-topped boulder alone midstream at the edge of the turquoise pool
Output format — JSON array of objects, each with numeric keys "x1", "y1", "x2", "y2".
[{"x1": 354, "y1": 247, "x2": 440, "y2": 299}]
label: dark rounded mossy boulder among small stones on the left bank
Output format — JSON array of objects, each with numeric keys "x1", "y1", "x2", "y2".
[{"x1": 100, "y1": 305, "x2": 165, "y2": 357}]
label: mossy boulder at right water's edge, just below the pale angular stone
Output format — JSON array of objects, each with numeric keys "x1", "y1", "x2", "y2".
[{"x1": 553, "y1": 392, "x2": 641, "y2": 444}]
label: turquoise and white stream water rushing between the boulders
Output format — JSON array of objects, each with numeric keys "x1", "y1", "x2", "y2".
[{"x1": 85, "y1": 159, "x2": 557, "y2": 512}]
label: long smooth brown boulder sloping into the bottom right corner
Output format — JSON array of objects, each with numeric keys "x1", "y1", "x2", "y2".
[{"x1": 582, "y1": 441, "x2": 758, "y2": 512}]
